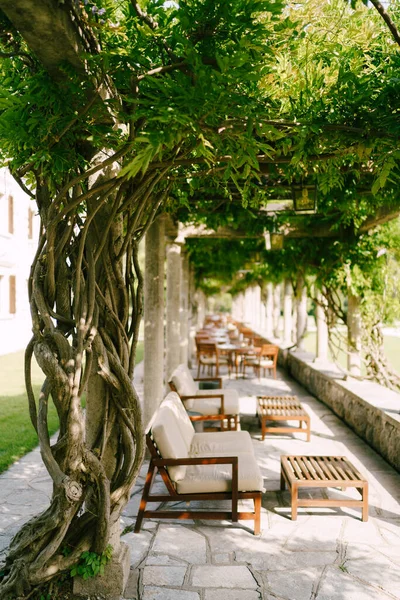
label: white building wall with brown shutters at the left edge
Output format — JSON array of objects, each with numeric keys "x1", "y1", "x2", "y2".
[{"x1": 0, "y1": 169, "x2": 39, "y2": 355}]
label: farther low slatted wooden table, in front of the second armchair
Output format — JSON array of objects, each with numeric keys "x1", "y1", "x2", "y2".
[{"x1": 257, "y1": 396, "x2": 310, "y2": 442}]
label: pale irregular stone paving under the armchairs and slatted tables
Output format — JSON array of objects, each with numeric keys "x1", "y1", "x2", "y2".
[{"x1": 0, "y1": 364, "x2": 400, "y2": 600}]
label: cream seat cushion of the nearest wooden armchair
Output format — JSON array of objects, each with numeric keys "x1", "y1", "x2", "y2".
[{"x1": 176, "y1": 454, "x2": 264, "y2": 494}]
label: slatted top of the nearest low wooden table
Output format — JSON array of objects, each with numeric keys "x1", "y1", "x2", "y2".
[{"x1": 281, "y1": 456, "x2": 366, "y2": 487}]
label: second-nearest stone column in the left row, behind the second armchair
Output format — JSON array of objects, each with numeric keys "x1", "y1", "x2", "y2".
[{"x1": 165, "y1": 242, "x2": 181, "y2": 382}]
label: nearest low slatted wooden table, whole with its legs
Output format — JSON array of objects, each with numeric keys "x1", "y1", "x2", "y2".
[{"x1": 281, "y1": 456, "x2": 368, "y2": 521}]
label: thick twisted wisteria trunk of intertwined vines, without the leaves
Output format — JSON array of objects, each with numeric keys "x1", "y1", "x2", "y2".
[{"x1": 0, "y1": 157, "x2": 166, "y2": 598}]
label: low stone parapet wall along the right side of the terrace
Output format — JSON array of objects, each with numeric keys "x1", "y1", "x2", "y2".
[{"x1": 280, "y1": 350, "x2": 400, "y2": 472}]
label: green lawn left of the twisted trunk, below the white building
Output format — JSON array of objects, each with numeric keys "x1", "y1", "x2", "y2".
[{"x1": 0, "y1": 342, "x2": 143, "y2": 473}]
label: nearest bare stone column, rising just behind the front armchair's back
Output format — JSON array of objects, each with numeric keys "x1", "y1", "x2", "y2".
[{"x1": 143, "y1": 216, "x2": 165, "y2": 426}]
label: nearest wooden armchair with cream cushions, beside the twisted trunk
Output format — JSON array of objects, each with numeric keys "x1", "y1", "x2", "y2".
[{"x1": 135, "y1": 392, "x2": 264, "y2": 534}]
